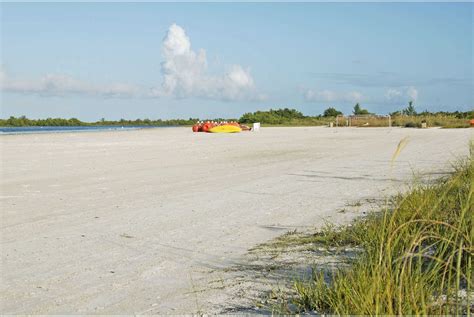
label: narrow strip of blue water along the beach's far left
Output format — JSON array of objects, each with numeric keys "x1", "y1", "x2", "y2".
[{"x1": 0, "y1": 126, "x2": 163, "y2": 135}]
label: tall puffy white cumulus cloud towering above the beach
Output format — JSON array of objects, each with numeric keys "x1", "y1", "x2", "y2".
[{"x1": 153, "y1": 24, "x2": 263, "y2": 100}]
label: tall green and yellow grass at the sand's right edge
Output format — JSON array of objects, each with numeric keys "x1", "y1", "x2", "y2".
[{"x1": 272, "y1": 146, "x2": 474, "y2": 315}]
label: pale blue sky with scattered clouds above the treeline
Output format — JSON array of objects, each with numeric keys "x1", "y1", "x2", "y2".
[{"x1": 0, "y1": 3, "x2": 474, "y2": 121}]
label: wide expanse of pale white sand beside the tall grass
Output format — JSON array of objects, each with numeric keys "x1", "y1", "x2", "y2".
[{"x1": 0, "y1": 128, "x2": 473, "y2": 314}]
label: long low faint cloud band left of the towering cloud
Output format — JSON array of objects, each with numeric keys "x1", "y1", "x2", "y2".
[{"x1": 0, "y1": 68, "x2": 140, "y2": 97}]
